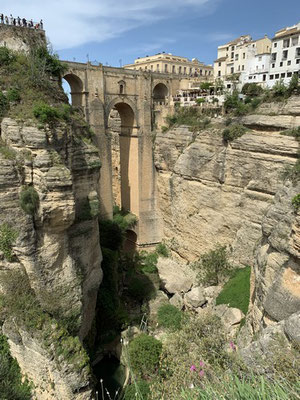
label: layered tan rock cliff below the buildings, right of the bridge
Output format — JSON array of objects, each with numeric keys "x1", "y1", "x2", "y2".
[{"x1": 155, "y1": 97, "x2": 300, "y2": 329}]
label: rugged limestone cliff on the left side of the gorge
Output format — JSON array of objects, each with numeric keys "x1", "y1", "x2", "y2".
[{"x1": 0, "y1": 118, "x2": 102, "y2": 400}]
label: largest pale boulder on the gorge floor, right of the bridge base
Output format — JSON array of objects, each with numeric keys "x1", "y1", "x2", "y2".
[{"x1": 157, "y1": 257, "x2": 196, "y2": 294}]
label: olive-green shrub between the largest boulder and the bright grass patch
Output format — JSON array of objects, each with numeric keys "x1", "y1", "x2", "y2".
[{"x1": 192, "y1": 244, "x2": 232, "y2": 285}]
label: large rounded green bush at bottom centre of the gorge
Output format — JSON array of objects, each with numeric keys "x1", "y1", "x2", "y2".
[{"x1": 128, "y1": 333, "x2": 162, "y2": 377}]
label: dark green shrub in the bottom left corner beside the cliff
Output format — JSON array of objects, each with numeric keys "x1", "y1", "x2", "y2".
[{"x1": 0, "y1": 335, "x2": 31, "y2": 400}]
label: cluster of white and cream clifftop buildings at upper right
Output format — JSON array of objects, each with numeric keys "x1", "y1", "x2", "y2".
[{"x1": 214, "y1": 23, "x2": 300, "y2": 89}]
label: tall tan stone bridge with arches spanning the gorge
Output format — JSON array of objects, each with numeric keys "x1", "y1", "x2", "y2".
[{"x1": 64, "y1": 62, "x2": 180, "y2": 245}]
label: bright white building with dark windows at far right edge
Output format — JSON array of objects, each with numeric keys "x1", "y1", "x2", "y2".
[{"x1": 267, "y1": 22, "x2": 300, "y2": 87}]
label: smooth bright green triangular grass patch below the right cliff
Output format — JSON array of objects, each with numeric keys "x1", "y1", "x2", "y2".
[{"x1": 216, "y1": 266, "x2": 251, "y2": 314}]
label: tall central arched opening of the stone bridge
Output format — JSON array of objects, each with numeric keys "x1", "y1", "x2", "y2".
[{"x1": 108, "y1": 102, "x2": 139, "y2": 215}]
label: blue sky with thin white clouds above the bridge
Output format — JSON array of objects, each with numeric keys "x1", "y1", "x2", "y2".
[{"x1": 0, "y1": 0, "x2": 300, "y2": 66}]
